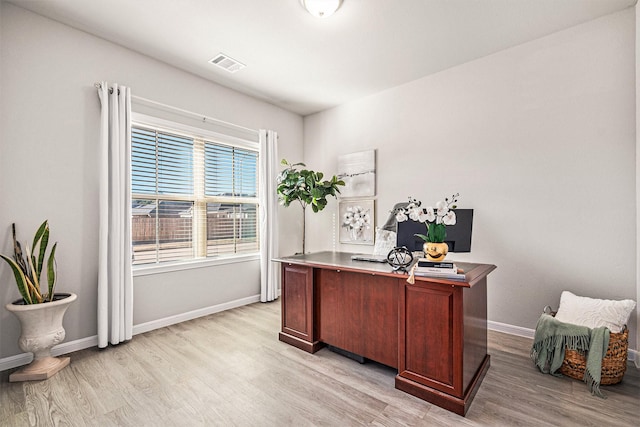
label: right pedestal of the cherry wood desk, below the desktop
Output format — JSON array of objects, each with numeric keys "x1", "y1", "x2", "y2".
[{"x1": 396, "y1": 277, "x2": 490, "y2": 415}]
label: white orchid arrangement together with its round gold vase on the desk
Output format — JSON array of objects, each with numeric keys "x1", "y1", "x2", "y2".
[{"x1": 395, "y1": 193, "x2": 460, "y2": 261}]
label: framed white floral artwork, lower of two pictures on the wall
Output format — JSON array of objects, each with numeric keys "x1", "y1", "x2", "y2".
[{"x1": 338, "y1": 200, "x2": 375, "y2": 245}]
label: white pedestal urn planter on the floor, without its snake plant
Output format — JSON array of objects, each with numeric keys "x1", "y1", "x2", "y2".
[{"x1": 6, "y1": 293, "x2": 77, "y2": 382}]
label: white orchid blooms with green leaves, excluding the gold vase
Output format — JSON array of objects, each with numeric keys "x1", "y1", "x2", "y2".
[{"x1": 396, "y1": 193, "x2": 460, "y2": 243}]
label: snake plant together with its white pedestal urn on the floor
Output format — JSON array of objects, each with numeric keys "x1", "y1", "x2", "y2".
[{"x1": 0, "y1": 221, "x2": 77, "y2": 382}]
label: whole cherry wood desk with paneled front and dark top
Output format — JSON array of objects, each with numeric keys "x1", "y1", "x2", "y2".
[{"x1": 275, "y1": 252, "x2": 496, "y2": 416}]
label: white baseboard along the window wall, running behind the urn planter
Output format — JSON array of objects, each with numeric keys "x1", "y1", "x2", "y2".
[{"x1": 0, "y1": 295, "x2": 260, "y2": 372}]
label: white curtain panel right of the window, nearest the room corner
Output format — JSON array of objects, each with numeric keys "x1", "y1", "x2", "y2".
[{"x1": 259, "y1": 129, "x2": 280, "y2": 302}]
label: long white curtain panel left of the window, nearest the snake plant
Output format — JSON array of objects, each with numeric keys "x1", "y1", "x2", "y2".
[{"x1": 96, "y1": 82, "x2": 133, "y2": 348}]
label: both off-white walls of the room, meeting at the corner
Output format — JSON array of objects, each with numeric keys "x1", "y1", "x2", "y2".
[{"x1": 0, "y1": 2, "x2": 640, "y2": 358}]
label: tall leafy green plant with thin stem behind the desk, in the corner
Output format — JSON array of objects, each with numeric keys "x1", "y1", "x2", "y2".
[{"x1": 276, "y1": 159, "x2": 344, "y2": 254}]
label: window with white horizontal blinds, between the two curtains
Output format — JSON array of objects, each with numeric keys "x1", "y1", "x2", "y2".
[{"x1": 131, "y1": 124, "x2": 259, "y2": 265}]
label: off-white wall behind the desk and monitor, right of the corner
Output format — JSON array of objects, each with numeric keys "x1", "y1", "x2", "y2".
[{"x1": 304, "y1": 9, "x2": 637, "y2": 346}]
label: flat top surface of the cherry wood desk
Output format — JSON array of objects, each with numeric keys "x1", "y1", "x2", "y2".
[{"x1": 273, "y1": 251, "x2": 496, "y2": 287}]
